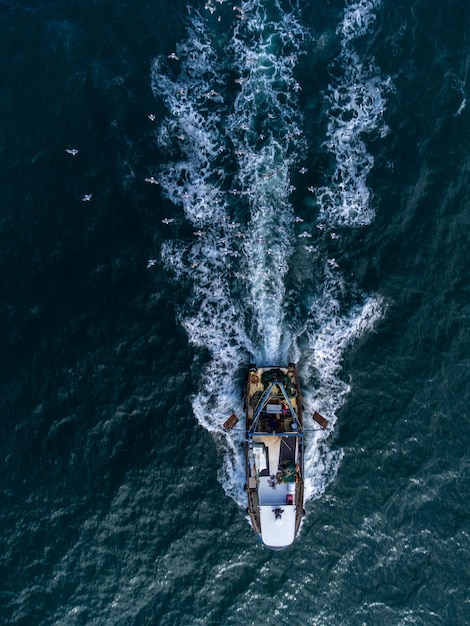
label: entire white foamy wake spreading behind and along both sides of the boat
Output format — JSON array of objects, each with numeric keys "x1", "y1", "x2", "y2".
[{"x1": 152, "y1": 0, "x2": 387, "y2": 506}]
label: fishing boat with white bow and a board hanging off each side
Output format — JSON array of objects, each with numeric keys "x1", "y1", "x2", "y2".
[{"x1": 224, "y1": 363, "x2": 328, "y2": 550}]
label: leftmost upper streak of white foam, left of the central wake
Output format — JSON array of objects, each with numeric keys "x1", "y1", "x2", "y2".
[{"x1": 152, "y1": 16, "x2": 230, "y2": 227}]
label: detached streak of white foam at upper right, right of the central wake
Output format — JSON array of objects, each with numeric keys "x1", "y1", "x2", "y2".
[{"x1": 316, "y1": 0, "x2": 390, "y2": 226}]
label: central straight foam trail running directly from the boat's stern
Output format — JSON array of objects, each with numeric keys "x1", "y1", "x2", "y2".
[{"x1": 227, "y1": 0, "x2": 306, "y2": 363}]
